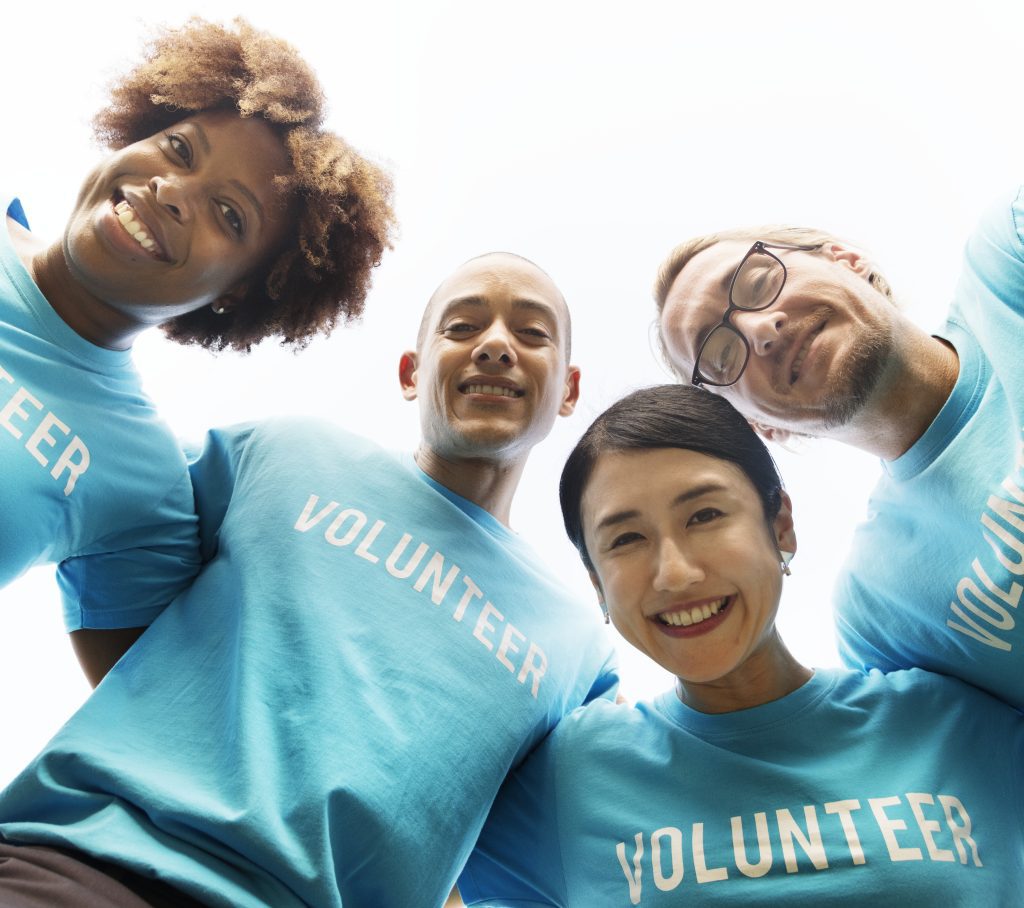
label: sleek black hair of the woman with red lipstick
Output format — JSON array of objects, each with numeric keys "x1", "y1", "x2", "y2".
[{"x1": 558, "y1": 385, "x2": 782, "y2": 570}]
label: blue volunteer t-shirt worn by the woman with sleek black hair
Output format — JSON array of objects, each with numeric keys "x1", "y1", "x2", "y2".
[{"x1": 459, "y1": 669, "x2": 1024, "y2": 908}]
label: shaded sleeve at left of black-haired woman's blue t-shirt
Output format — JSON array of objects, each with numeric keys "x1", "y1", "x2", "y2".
[{"x1": 459, "y1": 730, "x2": 568, "y2": 908}]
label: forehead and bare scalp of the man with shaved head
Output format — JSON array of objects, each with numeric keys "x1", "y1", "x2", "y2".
[{"x1": 426, "y1": 254, "x2": 568, "y2": 330}]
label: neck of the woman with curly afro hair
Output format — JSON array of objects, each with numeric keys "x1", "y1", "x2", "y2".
[{"x1": 26, "y1": 242, "x2": 146, "y2": 350}]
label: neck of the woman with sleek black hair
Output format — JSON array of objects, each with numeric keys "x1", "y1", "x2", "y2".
[{"x1": 676, "y1": 628, "x2": 814, "y2": 714}]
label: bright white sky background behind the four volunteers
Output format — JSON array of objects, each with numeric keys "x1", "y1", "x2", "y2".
[{"x1": 0, "y1": 0, "x2": 1024, "y2": 784}]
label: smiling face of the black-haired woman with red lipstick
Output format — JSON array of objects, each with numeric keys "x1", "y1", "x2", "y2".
[{"x1": 581, "y1": 447, "x2": 796, "y2": 684}]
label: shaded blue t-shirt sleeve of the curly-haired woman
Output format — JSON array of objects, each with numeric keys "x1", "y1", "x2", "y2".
[{"x1": 57, "y1": 464, "x2": 200, "y2": 632}]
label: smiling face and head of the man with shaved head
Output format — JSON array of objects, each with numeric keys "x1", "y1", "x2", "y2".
[{"x1": 399, "y1": 254, "x2": 580, "y2": 460}]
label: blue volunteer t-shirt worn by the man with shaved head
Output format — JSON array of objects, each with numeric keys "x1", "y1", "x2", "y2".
[{"x1": 0, "y1": 419, "x2": 615, "y2": 908}]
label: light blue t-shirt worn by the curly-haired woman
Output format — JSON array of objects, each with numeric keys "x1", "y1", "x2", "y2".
[{"x1": 0, "y1": 196, "x2": 200, "y2": 631}]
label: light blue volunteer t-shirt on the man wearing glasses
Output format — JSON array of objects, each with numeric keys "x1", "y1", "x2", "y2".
[{"x1": 836, "y1": 184, "x2": 1024, "y2": 709}]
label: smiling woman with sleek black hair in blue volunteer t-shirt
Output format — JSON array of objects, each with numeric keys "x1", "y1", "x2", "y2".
[{"x1": 460, "y1": 385, "x2": 1024, "y2": 906}]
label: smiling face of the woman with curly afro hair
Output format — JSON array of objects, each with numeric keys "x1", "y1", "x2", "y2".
[{"x1": 62, "y1": 112, "x2": 292, "y2": 326}]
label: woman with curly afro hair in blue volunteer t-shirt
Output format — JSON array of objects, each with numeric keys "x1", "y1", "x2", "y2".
[{"x1": 0, "y1": 19, "x2": 393, "y2": 683}]
